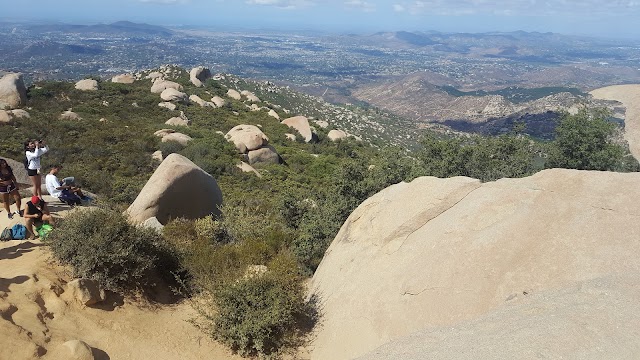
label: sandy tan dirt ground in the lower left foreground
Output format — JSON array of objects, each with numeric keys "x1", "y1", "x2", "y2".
[{"x1": 0, "y1": 197, "x2": 240, "y2": 360}]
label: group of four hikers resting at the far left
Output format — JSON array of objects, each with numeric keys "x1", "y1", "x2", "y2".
[{"x1": 0, "y1": 140, "x2": 87, "y2": 239}]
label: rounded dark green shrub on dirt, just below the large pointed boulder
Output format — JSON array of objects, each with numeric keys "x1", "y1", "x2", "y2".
[{"x1": 47, "y1": 208, "x2": 178, "y2": 291}]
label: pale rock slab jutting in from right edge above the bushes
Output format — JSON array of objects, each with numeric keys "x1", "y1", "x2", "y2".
[{"x1": 590, "y1": 84, "x2": 640, "y2": 160}]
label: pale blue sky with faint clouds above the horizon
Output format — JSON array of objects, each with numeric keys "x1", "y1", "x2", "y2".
[{"x1": 0, "y1": 0, "x2": 640, "y2": 40}]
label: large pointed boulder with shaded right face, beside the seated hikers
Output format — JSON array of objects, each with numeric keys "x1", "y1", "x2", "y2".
[{"x1": 127, "y1": 154, "x2": 222, "y2": 225}]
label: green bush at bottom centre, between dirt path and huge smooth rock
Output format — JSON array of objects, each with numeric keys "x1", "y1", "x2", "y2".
[{"x1": 210, "y1": 254, "x2": 313, "y2": 355}]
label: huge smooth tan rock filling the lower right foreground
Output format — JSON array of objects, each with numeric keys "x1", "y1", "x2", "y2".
[{"x1": 311, "y1": 169, "x2": 640, "y2": 359}]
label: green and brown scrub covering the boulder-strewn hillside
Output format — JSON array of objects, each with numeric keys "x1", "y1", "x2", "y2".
[{"x1": 0, "y1": 67, "x2": 639, "y2": 355}]
